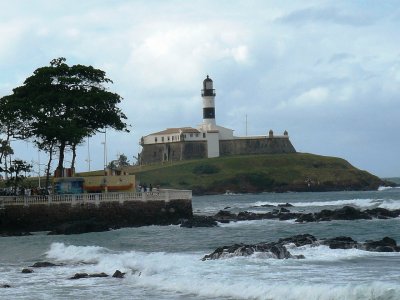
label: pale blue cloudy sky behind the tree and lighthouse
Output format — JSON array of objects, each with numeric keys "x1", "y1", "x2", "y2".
[{"x1": 0, "y1": 0, "x2": 400, "y2": 177}]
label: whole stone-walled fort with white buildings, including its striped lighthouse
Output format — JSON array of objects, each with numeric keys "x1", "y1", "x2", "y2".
[{"x1": 139, "y1": 75, "x2": 296, "y2": 164}]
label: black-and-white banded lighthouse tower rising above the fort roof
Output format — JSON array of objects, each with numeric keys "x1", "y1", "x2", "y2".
[{"x1": 201, "y1": 75, "x2": 216, "y2": 130}]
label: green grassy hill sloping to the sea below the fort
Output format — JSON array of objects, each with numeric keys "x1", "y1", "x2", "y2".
[{"x1": 123, "y1": 153, "x2": 384, "y2": 194}]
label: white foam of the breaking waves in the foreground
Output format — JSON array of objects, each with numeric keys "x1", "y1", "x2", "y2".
[{"x1": 39, "y1": 243, "x2": 400, "y2": 300}]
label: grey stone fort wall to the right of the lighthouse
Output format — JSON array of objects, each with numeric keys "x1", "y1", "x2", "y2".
[{"x1": 219, "y1": 137, "x2": 296, "y2": 156}]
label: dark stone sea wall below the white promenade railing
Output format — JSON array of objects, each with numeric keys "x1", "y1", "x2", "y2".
[{"x1": 0, "y1": 200, "x2": 192, "y2": 232}]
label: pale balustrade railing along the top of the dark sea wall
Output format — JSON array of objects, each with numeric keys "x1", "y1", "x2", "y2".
[{"x1": 0, "y1": 189, "x2": 192, "y2": 207}]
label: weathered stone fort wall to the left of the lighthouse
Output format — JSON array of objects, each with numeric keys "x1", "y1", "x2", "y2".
[{"x1": 140, "y1": 141, "x2": 207, "y2": 164}]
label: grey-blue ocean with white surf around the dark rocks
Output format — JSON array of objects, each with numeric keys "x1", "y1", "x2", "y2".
[{"x1": 0, "y1": 189, "x2": 400, "y2": 300}]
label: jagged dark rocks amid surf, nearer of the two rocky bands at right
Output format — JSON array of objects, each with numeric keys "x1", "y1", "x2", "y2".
[{"x1": 202, "y1": 234, "x2": 400, "y2": 261}]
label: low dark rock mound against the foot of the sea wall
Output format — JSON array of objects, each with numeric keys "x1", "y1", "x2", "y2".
[{"x1": 48, "y1": 220, "x2": 110, "y2": 235}]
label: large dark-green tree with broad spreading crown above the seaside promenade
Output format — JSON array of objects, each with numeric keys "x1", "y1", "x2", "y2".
[{"x1": 0, "y1": 57, "x2": 128, "y2": 177}]
